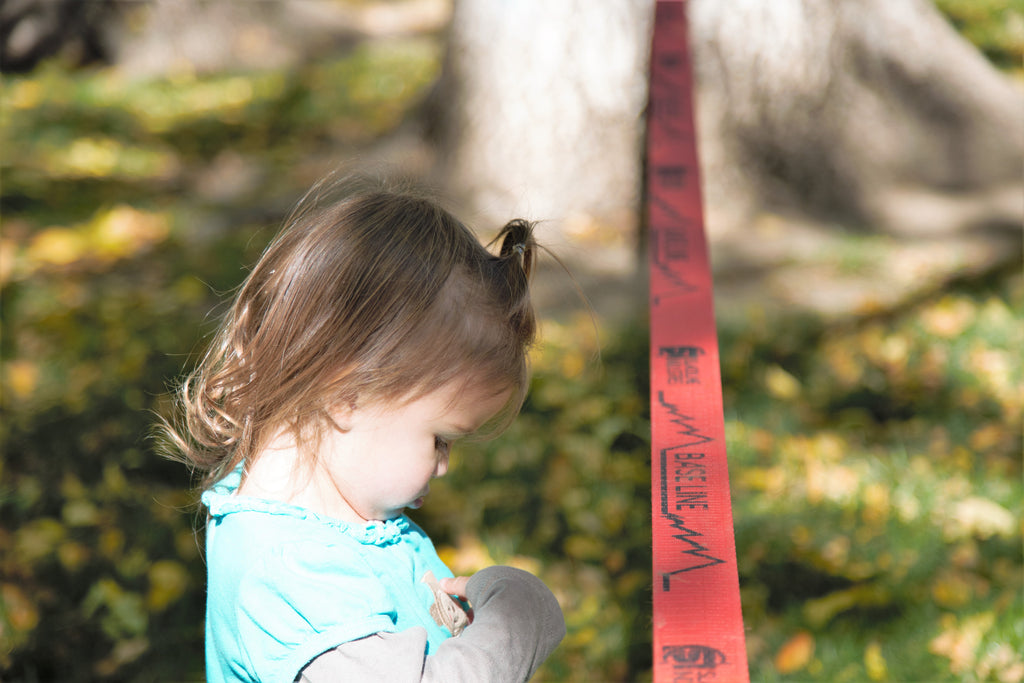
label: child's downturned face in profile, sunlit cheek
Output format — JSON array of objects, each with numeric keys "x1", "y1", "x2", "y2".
[{"x1": 318, "y1": 378, "x2": 511, "y2": 521}]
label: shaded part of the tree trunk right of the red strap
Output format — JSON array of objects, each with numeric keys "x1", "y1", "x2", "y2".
[{"x1": 691, "y1": 0, "x2": 1024, "y2": 232}]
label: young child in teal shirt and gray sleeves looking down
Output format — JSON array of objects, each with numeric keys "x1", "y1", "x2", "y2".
[{"x1": 169, "y1": 180, "x2": 565, "y2": 683}]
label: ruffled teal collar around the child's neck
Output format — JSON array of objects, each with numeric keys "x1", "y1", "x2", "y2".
[{"x1": 203, "y1": 468, "x2": 410, "y2": 546}]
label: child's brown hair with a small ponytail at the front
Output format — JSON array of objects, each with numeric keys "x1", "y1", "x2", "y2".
[{"x1": 166, "y1": 179, "x2": 537, "y2": 481}]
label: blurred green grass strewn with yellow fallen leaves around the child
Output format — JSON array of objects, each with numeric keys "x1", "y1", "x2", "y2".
[{"x1": 0, "y1": 0, "x2": 1024, "y2": 683}]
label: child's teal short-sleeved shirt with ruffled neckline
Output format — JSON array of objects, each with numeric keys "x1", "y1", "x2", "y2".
[{"x1": 203, "y1": 471, "x2": 452, "y2": 683}]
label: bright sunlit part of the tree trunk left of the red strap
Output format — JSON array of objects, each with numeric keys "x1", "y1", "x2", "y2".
[{"x1": 429, "y1": 0, "x2": 653, "y2": 253}]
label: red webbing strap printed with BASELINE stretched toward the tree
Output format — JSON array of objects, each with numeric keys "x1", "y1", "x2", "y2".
[{"x1": 647, "y1": 0, "x2": 750, "y2": 683}]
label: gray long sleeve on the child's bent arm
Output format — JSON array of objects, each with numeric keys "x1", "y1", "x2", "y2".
[{"x1": 298, "y1": 566, "x2": 565, "y2": 683}]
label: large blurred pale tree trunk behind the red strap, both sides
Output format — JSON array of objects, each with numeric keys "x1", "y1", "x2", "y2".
[{"x1": 431, "y1": 0, "x2": 1024, "y2": 241}]
